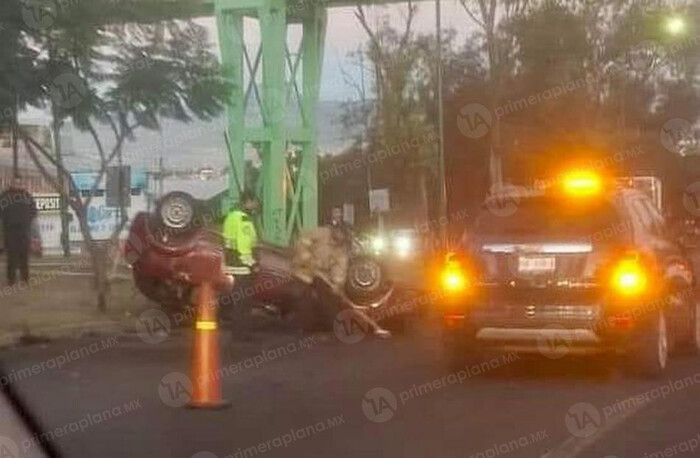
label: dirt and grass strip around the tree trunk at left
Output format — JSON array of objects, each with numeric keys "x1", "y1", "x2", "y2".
[{"x1": 0, "y1": 257, "x2": 146, "y2": 347}]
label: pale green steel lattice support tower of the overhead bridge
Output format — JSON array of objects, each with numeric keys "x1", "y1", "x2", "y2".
[{"x1": 105, "y1": 0, "x2": 410, "y2": 245}]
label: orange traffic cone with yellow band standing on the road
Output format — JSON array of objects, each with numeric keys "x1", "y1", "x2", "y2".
[{"x1": 187, "y1": 283, "x2": 231, "y2": 409}]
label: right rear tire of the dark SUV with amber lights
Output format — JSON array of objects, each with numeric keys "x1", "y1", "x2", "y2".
[{"x1": 627, "y1": 310, "x2": 669, "y2": 378}]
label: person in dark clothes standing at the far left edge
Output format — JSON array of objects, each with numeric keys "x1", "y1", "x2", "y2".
[{"x1": 0, "y1": 177, "x2": 36, "y2": 285}]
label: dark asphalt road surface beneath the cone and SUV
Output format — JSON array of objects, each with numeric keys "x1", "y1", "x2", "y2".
[{"x1": 0, "y1": 314, "x2": 700, "y2": 458}]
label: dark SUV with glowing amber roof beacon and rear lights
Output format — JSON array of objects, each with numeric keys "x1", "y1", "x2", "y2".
[{"x1": 439, "y1": 170, "x2": 700, "y2": 376}]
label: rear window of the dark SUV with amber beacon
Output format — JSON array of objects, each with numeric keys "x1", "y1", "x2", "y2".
[{"x1": 474, "y1": 197, "x2": 631, "y2": 242}]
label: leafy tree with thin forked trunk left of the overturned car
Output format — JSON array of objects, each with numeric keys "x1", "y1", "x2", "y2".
[{"x1": 11, "y1": 2, "x2": 229, "y2": 310}]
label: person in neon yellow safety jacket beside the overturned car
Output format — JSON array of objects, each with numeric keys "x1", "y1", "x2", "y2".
[{"x1": 223, "y1": 191, "x2": 260, "y2": 340}]
